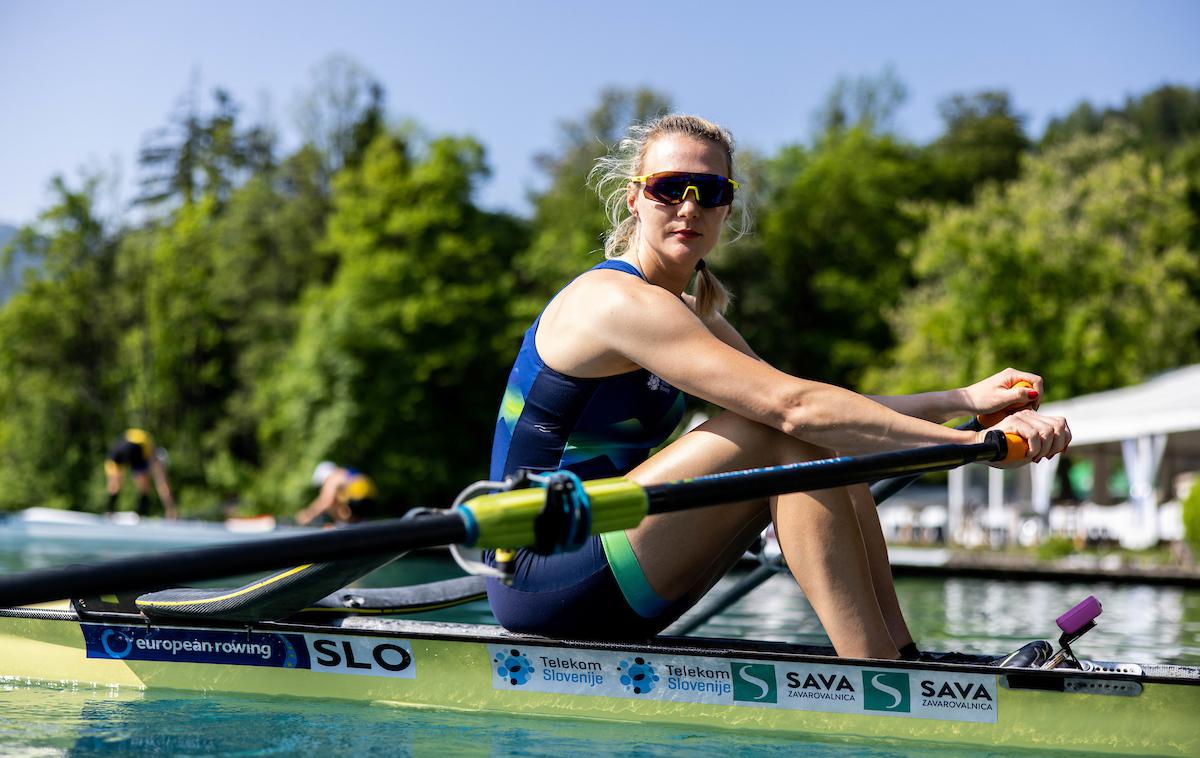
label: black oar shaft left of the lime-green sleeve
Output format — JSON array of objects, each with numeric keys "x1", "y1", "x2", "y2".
[{"x1": 0, "y1": 513, "x2": 467, "y2": 608}]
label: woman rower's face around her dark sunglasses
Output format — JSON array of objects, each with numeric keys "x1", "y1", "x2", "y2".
[{"x1": 626, "y1": 134, "x2": 730, "y2": 266}]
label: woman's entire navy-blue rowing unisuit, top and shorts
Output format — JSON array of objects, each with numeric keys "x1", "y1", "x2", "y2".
[{"x1": 487, "y1": 260, "x2": 685, "y2": 639}]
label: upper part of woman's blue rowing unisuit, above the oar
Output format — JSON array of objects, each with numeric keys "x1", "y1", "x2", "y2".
[{"x1": 491, "y1": 260, "x2": 684, "y2": 481}]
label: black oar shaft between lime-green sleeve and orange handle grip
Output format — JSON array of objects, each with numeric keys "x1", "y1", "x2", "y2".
[{"x1": 646, "y1": 433, "x2": 1007, "y2": 513}]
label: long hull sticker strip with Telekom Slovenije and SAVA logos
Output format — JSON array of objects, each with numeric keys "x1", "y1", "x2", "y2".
[{"x1": 487, "y1": 644, "x2": 997, "y2": 723}]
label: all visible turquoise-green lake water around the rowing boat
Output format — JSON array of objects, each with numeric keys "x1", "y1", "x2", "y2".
[{"x1": 0, "y1": 527, "x2": 1200, "y2": 758}]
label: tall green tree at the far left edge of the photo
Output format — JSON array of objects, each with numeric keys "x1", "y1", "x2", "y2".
[{"x1": 0, "y1": 176, "x2": 120, "y2": 509}]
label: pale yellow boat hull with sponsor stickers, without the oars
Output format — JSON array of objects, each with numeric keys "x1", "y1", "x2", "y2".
[{"x1": 0, "y1": 608, "x2": 1200, "y2": 756}]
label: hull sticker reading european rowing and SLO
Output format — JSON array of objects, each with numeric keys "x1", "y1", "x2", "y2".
[{"x1": 79, "y1": 624, "x2": 416, "y2": 679}]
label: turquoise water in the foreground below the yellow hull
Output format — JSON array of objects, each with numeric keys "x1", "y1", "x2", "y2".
[{"x1": 0, "y1": 684, "x2": 1065, "y2": 758}]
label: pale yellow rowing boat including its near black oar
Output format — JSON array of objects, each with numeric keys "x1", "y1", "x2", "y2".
[{"x1": 0, "y1": 435, "x2": 1200, "y2": 756}]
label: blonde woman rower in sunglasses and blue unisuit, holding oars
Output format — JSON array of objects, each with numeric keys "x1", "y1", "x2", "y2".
[{"x1": 488, "y1": 115, "x2": 1070, "y2": 658}]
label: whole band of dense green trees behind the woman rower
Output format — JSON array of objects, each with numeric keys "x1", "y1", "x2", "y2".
[{"x1": 0, "y1": 72, "x2": 1200, "y2": 516}]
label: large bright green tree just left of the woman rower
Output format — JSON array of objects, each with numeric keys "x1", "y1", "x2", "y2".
[{"x1": 254, "y1": 134, "x2": 526, "y2": 512}]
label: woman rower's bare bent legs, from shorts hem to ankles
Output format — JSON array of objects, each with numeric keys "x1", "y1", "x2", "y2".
[{"x1": 626, "y1": 411, "x2": 899, "y2": 658}]
